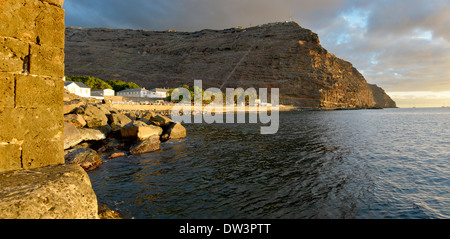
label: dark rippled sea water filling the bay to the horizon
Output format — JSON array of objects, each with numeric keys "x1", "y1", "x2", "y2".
[{"x1": 89, "y1": 108, "x2": 450, "y2": 219}]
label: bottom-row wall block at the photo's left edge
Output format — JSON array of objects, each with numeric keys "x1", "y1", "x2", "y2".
[{"x1": 0, "y1": 143, "x2": 22, "y2": 172}]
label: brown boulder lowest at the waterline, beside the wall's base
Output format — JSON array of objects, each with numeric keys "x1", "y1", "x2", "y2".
[{"x1": 65, "y1": 148, "x2": 103, "y2": 171}]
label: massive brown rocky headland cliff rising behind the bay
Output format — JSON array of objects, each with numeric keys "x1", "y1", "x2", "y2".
[{"x1": 65, "y1": 22, "x2": 396, "y2": 108}]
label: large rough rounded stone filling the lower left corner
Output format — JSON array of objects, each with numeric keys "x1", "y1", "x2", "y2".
[{"x1": 0, "y1": 165, "x2": 99, "y2": 219}]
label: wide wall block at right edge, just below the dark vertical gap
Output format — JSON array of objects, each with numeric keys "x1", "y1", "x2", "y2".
[{"x1": 16, "y1": 75, "x2": 64, "y2": 108}]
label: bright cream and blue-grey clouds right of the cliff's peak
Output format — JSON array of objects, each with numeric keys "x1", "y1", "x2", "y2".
[{"x1": 319, "y1": 0, "x2": 450, "y2": 94}]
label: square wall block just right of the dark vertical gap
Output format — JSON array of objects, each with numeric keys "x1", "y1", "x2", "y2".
[{"x1": 30, "y1": 44, "x2": 64, "y2": 78}]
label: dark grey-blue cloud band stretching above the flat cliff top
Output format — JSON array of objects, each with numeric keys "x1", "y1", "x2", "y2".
[{"x1": 64, "y1": 0, "x2": 349, "y2": 31}]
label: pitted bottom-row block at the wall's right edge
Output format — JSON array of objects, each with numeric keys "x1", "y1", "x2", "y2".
[{"x1": 22, "y1": 139, "x2": 65, "y2": 169}]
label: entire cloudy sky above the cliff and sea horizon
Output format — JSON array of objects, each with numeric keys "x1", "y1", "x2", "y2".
[{"x1": 64, "y1": 0, "x2": 450, "y2": 108}]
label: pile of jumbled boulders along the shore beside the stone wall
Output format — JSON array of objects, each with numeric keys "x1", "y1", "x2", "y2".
[{"x1": 63, "y1": 92, "x2": 186, "y2": 171}]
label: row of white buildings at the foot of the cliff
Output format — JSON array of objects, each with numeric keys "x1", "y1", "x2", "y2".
[{"x1": 64, "y1": 81, "x2": 169, "y2": 100}]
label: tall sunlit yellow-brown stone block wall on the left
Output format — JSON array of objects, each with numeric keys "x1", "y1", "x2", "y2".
[{"x1": 0, "y1": 0, "x2": 65, "y2": 172}]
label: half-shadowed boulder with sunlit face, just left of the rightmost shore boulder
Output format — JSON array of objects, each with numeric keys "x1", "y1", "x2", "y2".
[{"x1": 120, "y1": 121, "x2": 163, "y2": 141}]
